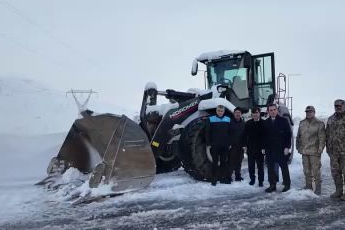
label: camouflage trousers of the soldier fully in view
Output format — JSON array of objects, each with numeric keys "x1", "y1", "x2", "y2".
[{"x1": 302, "y1": 155, "x2": 322, "y2": 187}]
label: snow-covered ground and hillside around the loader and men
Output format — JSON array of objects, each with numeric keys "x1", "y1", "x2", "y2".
[{"x1": 0, "y1": 77, "x2": 345, "y2": 229}]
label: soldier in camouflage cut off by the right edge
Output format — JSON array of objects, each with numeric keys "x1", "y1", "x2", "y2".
[{"x1": 326, "y1": 99, "x2": 345, "y2": 200}]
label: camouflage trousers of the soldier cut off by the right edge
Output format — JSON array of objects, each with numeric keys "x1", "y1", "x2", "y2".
[{"x1": 329, "y1": 153, "x2": 345, "y2": 186}]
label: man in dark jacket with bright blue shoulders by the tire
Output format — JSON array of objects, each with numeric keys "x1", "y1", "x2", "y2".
[{"x1": 206, "y1": 105, "x2": 231, "y2": 186}]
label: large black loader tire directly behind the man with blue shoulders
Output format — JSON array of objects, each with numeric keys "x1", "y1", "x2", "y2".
[{"x1": 180, "y1": 118, "x2": 212, "y2": 181}]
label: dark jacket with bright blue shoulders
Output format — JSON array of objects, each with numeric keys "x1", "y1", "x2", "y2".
[{"x1": 206, "y1": 115, "x2": 231, "y2": 148}]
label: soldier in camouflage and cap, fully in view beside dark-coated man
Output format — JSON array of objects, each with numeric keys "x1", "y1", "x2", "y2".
[{"x1": 296, "y1": 105, "x2": 326, "y2": 195}]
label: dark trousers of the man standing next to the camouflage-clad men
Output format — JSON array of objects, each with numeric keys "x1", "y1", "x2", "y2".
[{"x1": 267, "y1": 154, "x2": 291, "y2": 186}]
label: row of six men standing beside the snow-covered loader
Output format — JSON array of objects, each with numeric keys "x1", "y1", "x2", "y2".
[{"x1": 206, "y1": 99, "x2": 345, "y2": 200}]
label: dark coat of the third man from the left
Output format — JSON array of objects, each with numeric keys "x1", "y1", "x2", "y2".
[{"x1": 244, "y1": 119, "x2": 264, "y2": 156}]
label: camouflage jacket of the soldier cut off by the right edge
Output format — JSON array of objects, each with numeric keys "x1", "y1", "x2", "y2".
[{"x1": 326, "y1": 113, "x2": 345, "y2": 154}]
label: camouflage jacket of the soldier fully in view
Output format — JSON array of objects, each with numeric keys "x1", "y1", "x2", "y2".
[{"x1": 296, "y1": 118, "x2": 326, "y2": 156}]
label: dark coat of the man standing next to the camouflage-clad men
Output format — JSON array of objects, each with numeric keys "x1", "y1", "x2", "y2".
[{"x1": 264, "y1": 115, "x2": 292, "y2": 161}]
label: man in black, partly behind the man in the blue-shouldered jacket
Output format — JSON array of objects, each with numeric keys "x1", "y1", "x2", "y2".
[{"x1": 230, "y1": 107, "x2": 246, "y2": 181}]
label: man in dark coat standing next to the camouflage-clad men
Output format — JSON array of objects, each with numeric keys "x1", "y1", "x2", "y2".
[{"x1": 264, "y1": 104, "x2": 292, "y2": 193}]
